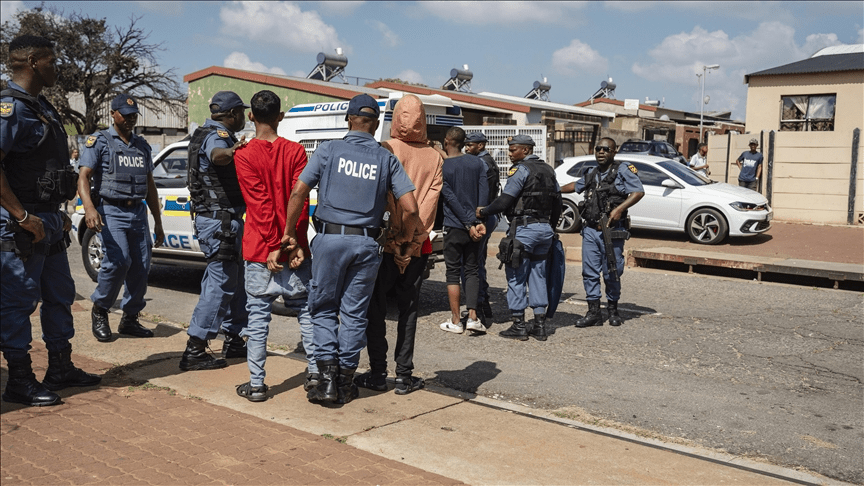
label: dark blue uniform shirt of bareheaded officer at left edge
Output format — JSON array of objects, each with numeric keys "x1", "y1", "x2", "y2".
[{"x1": 0, "y1": 81, "x2": 60, "y2": 159}]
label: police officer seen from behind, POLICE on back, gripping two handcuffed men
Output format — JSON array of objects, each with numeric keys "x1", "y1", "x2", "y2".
[{"x1": 276, "y1": 94, "x2": 424, "y2": 403}]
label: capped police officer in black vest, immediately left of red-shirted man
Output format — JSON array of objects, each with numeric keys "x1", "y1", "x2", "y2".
[{"x1": 180, "y1": 91, "x2": 249, "y2": 371}]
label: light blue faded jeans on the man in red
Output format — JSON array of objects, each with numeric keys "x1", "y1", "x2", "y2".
[{"x1": 240, "y1": 259, "x2": 318, "y2": 386}]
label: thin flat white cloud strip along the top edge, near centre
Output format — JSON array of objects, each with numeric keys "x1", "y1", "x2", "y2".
[{"x1": 412, "y1": 1, "x2": 587, "y2": 25}]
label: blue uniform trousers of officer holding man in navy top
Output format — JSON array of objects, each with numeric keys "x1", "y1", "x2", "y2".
[{"x1": 505, "y1": 223, "x2": 554, "y2": 315}]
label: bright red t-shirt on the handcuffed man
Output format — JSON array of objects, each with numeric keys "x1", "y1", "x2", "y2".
[{"x1": 234, "y1": 137, "x2": 310, "y2": 263}]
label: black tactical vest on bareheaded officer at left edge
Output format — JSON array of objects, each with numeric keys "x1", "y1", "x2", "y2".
[{"x1": 0, "y1": 89, "x2": 78, "y2": 204}]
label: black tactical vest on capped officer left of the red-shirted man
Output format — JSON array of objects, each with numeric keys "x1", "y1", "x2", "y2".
[{"x1": 186, "y1": 126, "x2": 246, "y2": 212}]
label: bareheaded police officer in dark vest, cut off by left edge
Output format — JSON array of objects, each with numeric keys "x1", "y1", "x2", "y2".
[{"x1": 0, "y1": 35, "x2": 102, "y2": 406}]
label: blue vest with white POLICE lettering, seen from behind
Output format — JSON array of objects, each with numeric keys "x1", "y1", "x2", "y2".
[{"x1": 315, "y1": 140, "x2": 390, "y2": 228}]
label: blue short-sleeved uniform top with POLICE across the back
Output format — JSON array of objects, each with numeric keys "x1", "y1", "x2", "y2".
[{"x1": 300, "y1": 131, "x2": 414, "y2": 228}]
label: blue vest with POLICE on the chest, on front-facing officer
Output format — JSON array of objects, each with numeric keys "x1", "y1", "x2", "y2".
[{"x1": 99, "y1": 130, "x2": 149, "y2": 200}]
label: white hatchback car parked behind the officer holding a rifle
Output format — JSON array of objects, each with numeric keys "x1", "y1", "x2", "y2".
[{"x1": 555, "y1": 153, "x2": 774, "y2": 245}]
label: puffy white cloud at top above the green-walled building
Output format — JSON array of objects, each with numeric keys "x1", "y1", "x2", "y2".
[{"x1": 219, "y1": 2, "x2": 350, "y2": 53}]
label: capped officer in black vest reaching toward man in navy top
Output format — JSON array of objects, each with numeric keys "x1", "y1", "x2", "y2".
[{"x1": 477, "y1": 135, "x2": 561, "y2": 341}]
